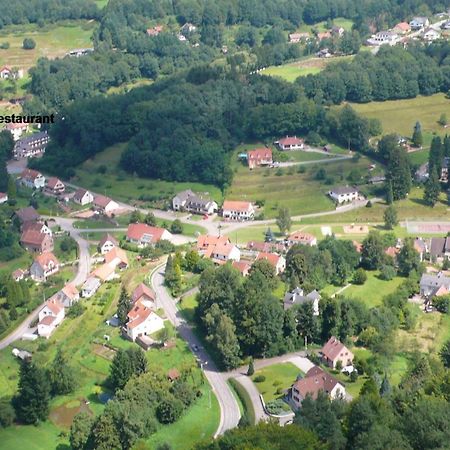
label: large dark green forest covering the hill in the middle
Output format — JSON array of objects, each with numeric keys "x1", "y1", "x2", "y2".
[{"x1": 33, "y1": 67, "x2": 379, "y2": 186}]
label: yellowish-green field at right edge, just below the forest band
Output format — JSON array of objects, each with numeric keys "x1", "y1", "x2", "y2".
[{"x1": 351, "y1": 94, "x2": 450, "y2": 136}]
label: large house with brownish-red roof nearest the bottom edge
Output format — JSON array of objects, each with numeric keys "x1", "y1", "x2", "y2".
[{"x1": 290, "y1": 366, "x2": 346, "y2": 409}]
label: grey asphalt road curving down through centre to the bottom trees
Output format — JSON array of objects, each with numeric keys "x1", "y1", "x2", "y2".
[{"x1": 150, "y1": 265, "x2": 241, "y2": 437}]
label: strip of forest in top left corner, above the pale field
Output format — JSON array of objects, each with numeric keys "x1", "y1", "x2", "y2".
[{"x1": 0, "y1": 0, "x2": 100, "y2": 29}]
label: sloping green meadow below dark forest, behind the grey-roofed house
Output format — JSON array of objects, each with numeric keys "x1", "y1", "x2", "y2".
[{"x1": 76, "y1": 144, "x2": 222, "y2": 207}]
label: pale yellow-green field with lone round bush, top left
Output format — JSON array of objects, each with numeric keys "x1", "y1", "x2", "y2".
[{"x1": 0, "y1": 21, "x2": 96, "y2": 69}]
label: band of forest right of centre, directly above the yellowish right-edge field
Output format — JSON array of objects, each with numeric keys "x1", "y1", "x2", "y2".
[{"x1": 297, "y1": 42, "x2": 450, "y2": 104}]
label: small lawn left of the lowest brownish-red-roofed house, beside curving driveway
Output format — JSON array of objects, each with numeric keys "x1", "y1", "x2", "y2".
[{"x1": 252, "y1": 363, "x2": 301, "y2": 403}]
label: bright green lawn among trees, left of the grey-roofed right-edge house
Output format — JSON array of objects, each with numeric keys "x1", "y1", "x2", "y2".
[{"x1": 342, "y1": 271, "x2": 404, "y2": 308}]
